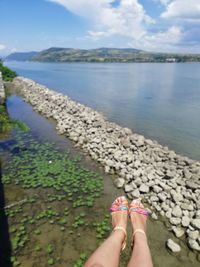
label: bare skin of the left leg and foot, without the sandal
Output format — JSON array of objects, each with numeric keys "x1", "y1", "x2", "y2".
[{"x1": 85, "y1": 199, "x2": 128, "y2": 267}]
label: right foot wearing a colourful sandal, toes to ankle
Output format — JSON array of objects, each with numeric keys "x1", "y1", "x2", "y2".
[{"x1": 129, "y1": 199, "x2": 148, "y2": 241}]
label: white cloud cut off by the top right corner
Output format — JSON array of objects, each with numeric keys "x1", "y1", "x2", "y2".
[{"x1": 161, "y1": 0, "x2": 200, "y2": 19}]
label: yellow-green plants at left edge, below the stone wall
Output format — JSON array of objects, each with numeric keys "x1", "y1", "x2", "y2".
[{"x1": 0, "y1": 104, "x2": 29, "y2": 133}]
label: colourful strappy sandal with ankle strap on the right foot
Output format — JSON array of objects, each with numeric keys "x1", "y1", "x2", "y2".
[{"x1": 129, "y1": 199, "x2": 148, "y2": 247}]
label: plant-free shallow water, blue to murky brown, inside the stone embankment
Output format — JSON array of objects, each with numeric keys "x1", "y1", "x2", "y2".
[{"x1": 0, "y1": 96, "x2": 199, "y2": 267}]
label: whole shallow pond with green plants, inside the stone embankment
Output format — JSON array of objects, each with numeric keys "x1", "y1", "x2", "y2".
[{"x1": 0, "y1": 96, "x2": 199, "y2": 267}]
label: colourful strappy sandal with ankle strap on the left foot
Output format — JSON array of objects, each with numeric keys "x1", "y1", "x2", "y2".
[{"x1": 110, "y1": 196, "x2": 129, "y2": 250}]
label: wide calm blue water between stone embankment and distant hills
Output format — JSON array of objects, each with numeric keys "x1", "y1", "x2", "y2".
[{"x1": 6, "y1": 62, "x2": 200, "y2": 160}]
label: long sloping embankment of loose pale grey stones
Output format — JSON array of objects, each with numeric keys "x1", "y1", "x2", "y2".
[{"x1": 14, "y1": 77, "x2": 200, "y2": 251}]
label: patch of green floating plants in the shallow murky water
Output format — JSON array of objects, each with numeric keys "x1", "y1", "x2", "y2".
[{"x1": 0, "y1": 131, "x2": 110, "y2": 267}]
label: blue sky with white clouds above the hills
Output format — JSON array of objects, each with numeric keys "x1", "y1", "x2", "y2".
[{"x1": 0, "y1": 0, "x2": 200, "y2": 56}]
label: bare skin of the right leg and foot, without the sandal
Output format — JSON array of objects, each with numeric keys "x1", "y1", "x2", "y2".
[{"x1": 128, "y1": 202, "x2": 153, "y2": 267}]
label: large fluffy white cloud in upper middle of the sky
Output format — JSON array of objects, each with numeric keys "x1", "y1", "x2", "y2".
[{"x1": 47, "y1": 0, "x2": 186, "y2": 51}]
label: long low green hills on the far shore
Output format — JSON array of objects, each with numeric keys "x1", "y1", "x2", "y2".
[{"x1": 6, "y1": 47, "x2": 200, "y2": 63}]
